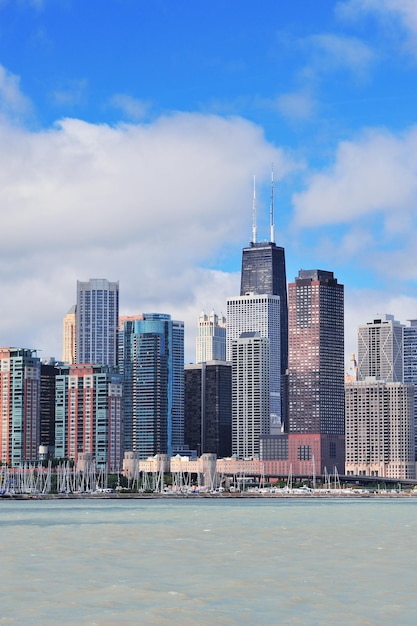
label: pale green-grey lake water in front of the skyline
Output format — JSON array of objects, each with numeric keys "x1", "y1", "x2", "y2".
[{"x1": 0, "y1": 498, "x2": 417, "y2": 626}]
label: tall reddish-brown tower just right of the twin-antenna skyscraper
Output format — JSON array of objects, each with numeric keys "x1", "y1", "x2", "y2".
[{"x1": 288, "y1": 270, "x2": 344, "y2": 473}]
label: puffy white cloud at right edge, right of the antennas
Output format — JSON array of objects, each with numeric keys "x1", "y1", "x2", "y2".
[{"x1": 293, "y1": 127, "x2": 417, "y2": 228}]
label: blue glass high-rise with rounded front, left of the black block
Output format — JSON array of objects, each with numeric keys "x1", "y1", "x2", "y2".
[{"x1": 123, "y1": 313, "x2": 184, "y2": 459}]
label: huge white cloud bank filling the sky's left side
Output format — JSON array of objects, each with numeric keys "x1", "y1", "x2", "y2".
[{"x1": 0, "y1": 109, "x2": 292, "y2": 360}]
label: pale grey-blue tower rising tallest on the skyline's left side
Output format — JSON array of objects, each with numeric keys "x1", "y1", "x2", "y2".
[{"x1": 76, "y1": 278, "x2": 119, "y2": 366}]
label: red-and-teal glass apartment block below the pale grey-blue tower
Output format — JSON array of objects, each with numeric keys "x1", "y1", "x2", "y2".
[{"x1": 55, "y1": 364, "x2": 123, "y2": 472}]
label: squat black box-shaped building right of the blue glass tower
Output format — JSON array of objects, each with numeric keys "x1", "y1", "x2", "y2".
[{"x1": 184, "y1": 361, "x2": 232, "y2": 457}]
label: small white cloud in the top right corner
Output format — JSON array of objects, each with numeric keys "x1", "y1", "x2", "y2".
[{"x1": 336, "y1": 0, "x2": 417, "y2": 55}]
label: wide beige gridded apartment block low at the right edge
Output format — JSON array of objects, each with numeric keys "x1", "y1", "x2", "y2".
[{"x1": 345, "y1": 376, "x2": 416, "y2": 479}]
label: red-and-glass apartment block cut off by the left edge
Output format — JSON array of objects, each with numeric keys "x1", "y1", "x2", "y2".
[{"x1": 0, "y1": 348, "x2": 41, "y2": 467}]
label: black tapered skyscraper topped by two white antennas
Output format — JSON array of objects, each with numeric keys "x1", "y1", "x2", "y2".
[{"x1": 240, "y1": 179, "x2": 288, "y2": 427}]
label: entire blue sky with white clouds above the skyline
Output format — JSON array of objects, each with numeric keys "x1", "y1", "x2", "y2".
[{"x1": 0, "y1": 0, "x2": 417, "y2": 362}]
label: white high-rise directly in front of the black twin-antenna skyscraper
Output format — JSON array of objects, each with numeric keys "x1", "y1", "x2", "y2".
[{"x1": 227, "y1": 294, "x2": 282, "y2": 434}]
